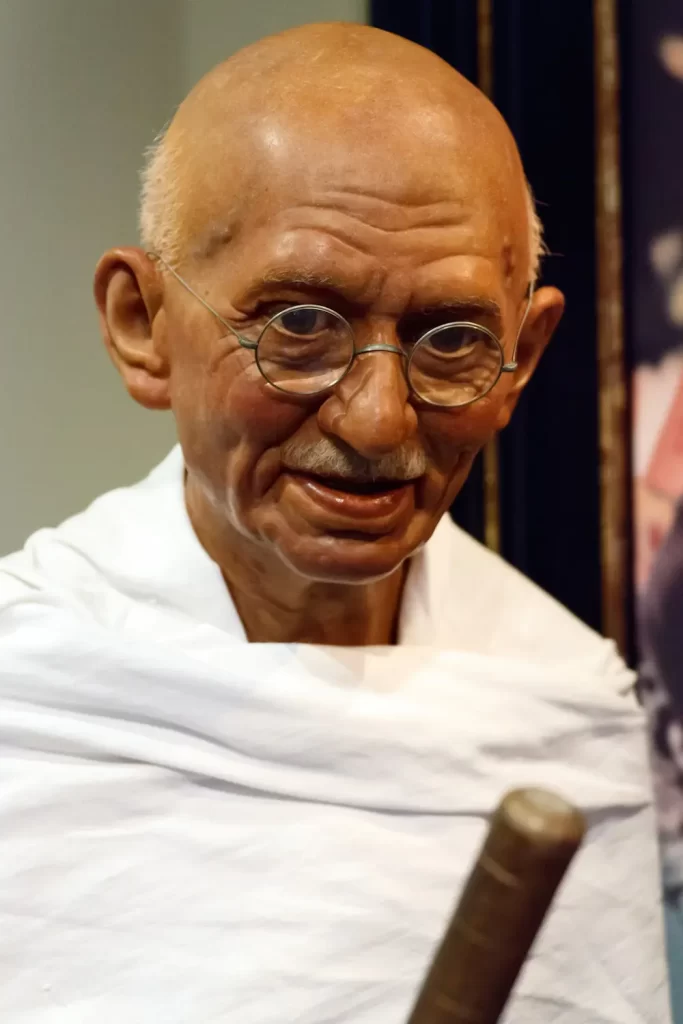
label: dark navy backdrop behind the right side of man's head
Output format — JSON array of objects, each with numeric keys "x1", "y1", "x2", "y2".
[{"x1": 371, "y1": 0, "x2": 601, "y2": 630}]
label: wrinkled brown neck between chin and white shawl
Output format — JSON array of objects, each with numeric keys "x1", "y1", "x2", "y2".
[{"x1": 186, "y1": 479, "x2": 407, "y2": 647}]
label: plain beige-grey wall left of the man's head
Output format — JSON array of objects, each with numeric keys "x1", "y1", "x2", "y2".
[{"x1": 0, "y1": 0, "x2": 365, "y2": 553}]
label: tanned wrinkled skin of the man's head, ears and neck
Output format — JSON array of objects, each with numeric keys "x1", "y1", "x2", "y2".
[{"x1": 95, "y1": 25, "x2": 563, "y2": 644}]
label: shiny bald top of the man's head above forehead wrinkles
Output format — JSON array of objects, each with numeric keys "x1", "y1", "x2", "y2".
[{"x1": 140, "y1": 24, "x2": 541, "y2": 279}]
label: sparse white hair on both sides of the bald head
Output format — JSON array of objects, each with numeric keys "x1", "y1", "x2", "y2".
[{"x1": 138, "y1": 125, "x2": 546, "y2": 284}]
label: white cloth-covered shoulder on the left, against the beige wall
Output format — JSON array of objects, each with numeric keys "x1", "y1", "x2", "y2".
[{"x1": 0, "y1": 446, "x2": 239, "y2": 638}]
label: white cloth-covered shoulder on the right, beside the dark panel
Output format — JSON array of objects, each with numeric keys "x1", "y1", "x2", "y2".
[{"x1": 403, "y1": 516, "x2": 631, "y2": 680}]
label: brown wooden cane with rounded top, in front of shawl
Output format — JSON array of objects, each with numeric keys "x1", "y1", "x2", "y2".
[{"x1": 409, "y1": 790, "x2": 586, "y2": 1024}]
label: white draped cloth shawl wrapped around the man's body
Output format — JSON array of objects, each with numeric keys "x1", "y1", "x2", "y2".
[{"x1": 0, "y1": 450, "x2": 669, "y2": 1024}]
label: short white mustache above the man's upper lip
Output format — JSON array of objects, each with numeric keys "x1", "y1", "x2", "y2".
[{"x1": 281, "y1": 437, "x2": 429, "y2": 483}]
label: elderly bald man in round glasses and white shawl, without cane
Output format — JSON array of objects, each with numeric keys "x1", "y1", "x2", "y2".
[{"x1": 0, "y1": 18, "x2": 668, "y2": 1024}]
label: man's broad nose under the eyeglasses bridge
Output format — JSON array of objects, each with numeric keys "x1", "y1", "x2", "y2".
[{"x1": 318, "y1": 351, "x2": 418, "y2": 459}]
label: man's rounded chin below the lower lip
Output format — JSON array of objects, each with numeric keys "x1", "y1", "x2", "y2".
[{"x1": 275, "y1": 536, "x2": 422, "y2": 585}]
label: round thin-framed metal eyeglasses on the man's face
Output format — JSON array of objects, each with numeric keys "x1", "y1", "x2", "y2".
[{"x1": 148, "y1": 253, "x2": 530, "y2": 409}]
